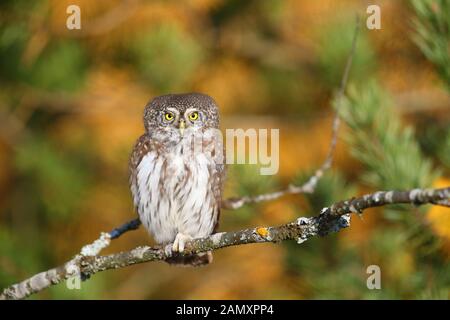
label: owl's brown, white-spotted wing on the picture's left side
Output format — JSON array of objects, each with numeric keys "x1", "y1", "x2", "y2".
[{"x1": 129, "y1": 134, "x2": 154, "y2": 209}]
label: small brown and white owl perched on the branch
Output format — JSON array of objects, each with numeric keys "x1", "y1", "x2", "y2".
[{"x1": 130, "y1": 93, "x2": 225, "y2": 266}]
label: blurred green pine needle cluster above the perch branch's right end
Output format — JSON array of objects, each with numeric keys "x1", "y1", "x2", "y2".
[{"x1": 334, "y1": 82, "x2": 439, "y2": 189}]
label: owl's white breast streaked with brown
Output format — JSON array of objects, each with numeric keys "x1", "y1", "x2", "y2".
[{"x1": 135, "y1": 144, "x2": 218, "y2": 243}]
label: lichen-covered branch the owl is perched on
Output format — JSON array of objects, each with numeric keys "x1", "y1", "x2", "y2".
[{"x1": 0, "y1": 186, "x2": 450, "y2": 299}]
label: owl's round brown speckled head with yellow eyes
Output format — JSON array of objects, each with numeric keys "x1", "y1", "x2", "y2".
[{"x1": 144, "y1": 93, "x2": 219, "y2": 136}]
